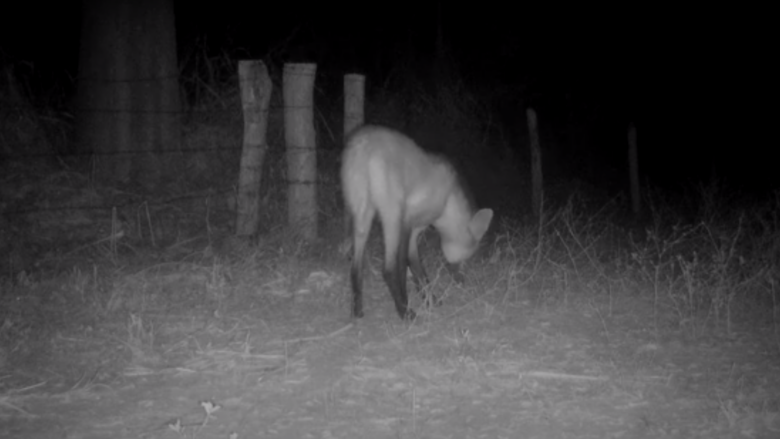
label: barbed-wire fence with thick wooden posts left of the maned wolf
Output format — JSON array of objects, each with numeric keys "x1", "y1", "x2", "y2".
[{"x1": 0, "y1": 68, "x2": 500, "y2": 229}]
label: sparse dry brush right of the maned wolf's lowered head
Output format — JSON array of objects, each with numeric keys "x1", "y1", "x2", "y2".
[{"x1": 488, "y1": 186, "x2": 780, "y2": 336}]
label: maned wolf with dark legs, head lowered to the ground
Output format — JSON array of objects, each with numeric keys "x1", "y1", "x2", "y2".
[{"x1": 341, "y1": 125, "x2": 493, "y2": 320}]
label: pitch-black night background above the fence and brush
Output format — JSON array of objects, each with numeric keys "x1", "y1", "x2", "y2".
[{"x1": 0, "y1": 1, "x2": 780, "y2": 196}]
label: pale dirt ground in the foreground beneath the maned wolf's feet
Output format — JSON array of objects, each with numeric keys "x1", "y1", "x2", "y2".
[{"x1": 0, "y1": 253, "x2": 780, "y2": 439}]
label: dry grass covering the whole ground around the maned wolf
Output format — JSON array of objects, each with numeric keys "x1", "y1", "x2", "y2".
[{"x1": 0, "y1": 59, "x2": 780, "y2": 437}]
